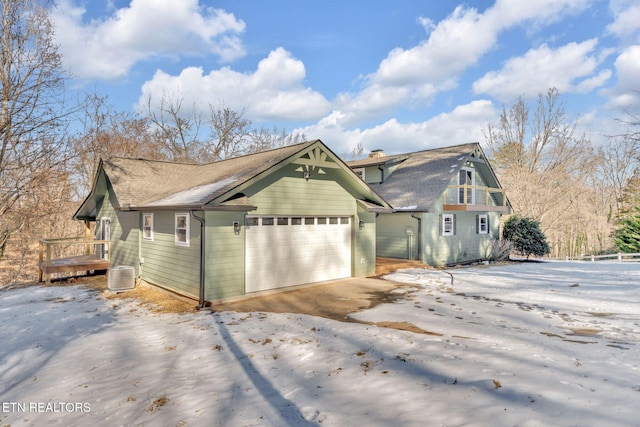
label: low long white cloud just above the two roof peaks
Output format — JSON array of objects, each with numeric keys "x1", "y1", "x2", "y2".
[{"x1": 296, "y1": 100, "x2": 497, "y2": 155}]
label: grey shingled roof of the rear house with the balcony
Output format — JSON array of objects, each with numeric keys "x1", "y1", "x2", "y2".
[{"x1": 348, "y1": 143, "x2": 499, "y2": 212}]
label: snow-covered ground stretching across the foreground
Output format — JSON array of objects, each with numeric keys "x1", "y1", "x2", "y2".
[{"x1": 0, "y1": 262, "x2": 640, "y2": 426}]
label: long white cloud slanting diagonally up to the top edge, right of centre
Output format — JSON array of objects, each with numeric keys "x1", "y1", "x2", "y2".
[{"x1": 337, "y1": 0, "x2": 588, "y2": 123}]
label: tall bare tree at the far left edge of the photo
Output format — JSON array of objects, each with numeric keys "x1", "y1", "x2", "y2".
[{"x1": 0, "y1": 0, "x2": 75, "y2": 270}]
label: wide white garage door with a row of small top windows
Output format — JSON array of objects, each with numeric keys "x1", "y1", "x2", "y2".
[{"x1": 245, "y1": 216, "x2": 351, "y2": 292}]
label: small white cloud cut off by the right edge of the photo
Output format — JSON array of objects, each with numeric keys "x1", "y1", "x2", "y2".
[{"x1": 603, "y1": 45, "x2": 640, "y2": 113}]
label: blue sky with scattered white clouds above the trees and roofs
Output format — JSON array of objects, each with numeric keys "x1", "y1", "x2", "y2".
[{"x1": 52, "y1": 0, "x2": 640, "y2": 154}]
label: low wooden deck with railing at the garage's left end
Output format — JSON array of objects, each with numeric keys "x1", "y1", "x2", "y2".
[{"x1": 38, "y1": 237, "x2": 110, "y2": 282}]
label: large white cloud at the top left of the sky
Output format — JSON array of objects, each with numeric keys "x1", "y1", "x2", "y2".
[{"x1": 51, "y1": 0, "x2": 245, "y2": 79}]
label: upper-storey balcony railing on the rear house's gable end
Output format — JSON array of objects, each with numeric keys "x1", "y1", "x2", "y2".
[{"x1": 444, "y1": 185, "x2": 508, "y2": 212}]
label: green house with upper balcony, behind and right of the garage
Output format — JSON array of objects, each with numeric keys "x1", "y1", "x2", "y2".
[{"x1": 349, "y1": 143, "x2": 511, "y2": 266}]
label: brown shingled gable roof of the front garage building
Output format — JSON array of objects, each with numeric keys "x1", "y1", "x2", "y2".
[{"x1": 74, "y1": 140, "x2": 389, "y2": 219}]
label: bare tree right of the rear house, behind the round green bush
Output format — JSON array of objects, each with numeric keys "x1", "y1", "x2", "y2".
[{"x1": 484, "y1": 88, "x2": 593, "y2": 255}]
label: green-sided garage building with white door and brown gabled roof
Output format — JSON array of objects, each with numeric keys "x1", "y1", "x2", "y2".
[{"x1": 74, "y1": 140, "x2": 391, "y2": 305}]
